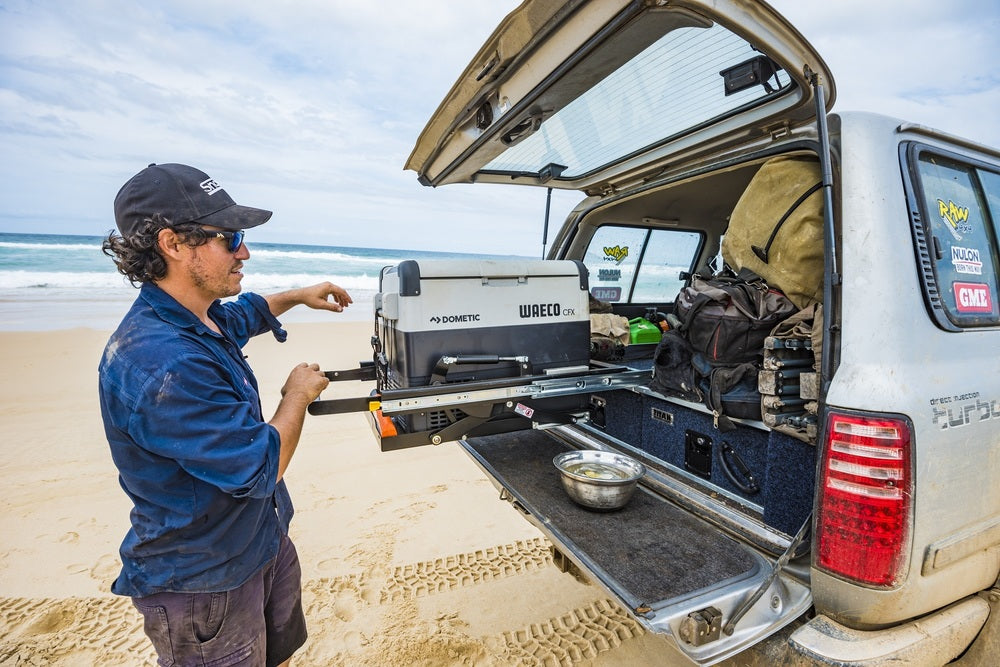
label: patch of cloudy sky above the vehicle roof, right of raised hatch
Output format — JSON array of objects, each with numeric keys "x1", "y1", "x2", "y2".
[{"x1": 772, "y1": 0, "x2": 1000, "y2": 145}]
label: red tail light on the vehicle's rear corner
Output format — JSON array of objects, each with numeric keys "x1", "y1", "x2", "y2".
[{"x1": 816, "y1": 412, "x2": 913, "y2": 587}]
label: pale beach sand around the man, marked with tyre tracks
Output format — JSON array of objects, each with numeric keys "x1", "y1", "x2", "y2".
[{"x1": 0, "y1": 316, "x2": 675, "y2": 666}]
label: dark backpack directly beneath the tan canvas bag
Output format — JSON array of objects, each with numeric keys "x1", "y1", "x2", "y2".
[{"x1": 674, "y1": 269, "x2": 798, "y2": 364}]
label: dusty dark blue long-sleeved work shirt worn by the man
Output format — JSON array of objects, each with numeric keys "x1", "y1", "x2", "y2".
[{"x1": 100, "y1": 283, "x2": 292, "y2": 597}]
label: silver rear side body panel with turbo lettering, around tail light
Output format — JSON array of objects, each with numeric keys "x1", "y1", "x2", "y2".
[{"x1": 813, "y1": 114, "x2": 1000, "y2": 626}]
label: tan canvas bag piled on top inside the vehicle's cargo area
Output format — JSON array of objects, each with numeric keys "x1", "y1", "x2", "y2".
[{"x1": 722, "y1": 156, "x2": 823, "y2": 308}]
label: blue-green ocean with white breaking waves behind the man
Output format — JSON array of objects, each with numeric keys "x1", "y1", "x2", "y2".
[{"x1": 0, "y1": 232, "x2": 523, "y2": 331}]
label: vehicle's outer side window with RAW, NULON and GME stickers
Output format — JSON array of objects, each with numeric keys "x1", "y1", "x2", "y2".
[{"x1": 917, "y1": 152, "x2": 1000, "y2": 327}]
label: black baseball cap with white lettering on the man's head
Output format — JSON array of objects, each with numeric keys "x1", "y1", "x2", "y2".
[{"x1": 115, "y1": 164, "x2": 271, "y2": 236}]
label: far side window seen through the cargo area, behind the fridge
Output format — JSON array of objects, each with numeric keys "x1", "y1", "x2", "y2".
[{"x1": 583, "y1": 225, "x2": 701, "y2": 303}]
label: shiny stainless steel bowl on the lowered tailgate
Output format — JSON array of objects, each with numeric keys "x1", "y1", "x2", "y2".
[{"x1": 552, "y1": 449, "x2": 646, "y2": 512}]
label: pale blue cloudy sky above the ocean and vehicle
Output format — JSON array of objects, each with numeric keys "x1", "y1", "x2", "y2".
[{"x1": 0, "y1": 0, "x2": 1000, "y2": 256}]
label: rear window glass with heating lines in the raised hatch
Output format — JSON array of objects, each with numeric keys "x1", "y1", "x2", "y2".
[{"x1": 484, "y1": 22, "x2": 795, "y2": 179}]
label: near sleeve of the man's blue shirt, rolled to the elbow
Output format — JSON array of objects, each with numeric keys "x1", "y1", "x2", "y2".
[{"x1": 128, "y1": 353, "x2": 281, "y2": 498}]
